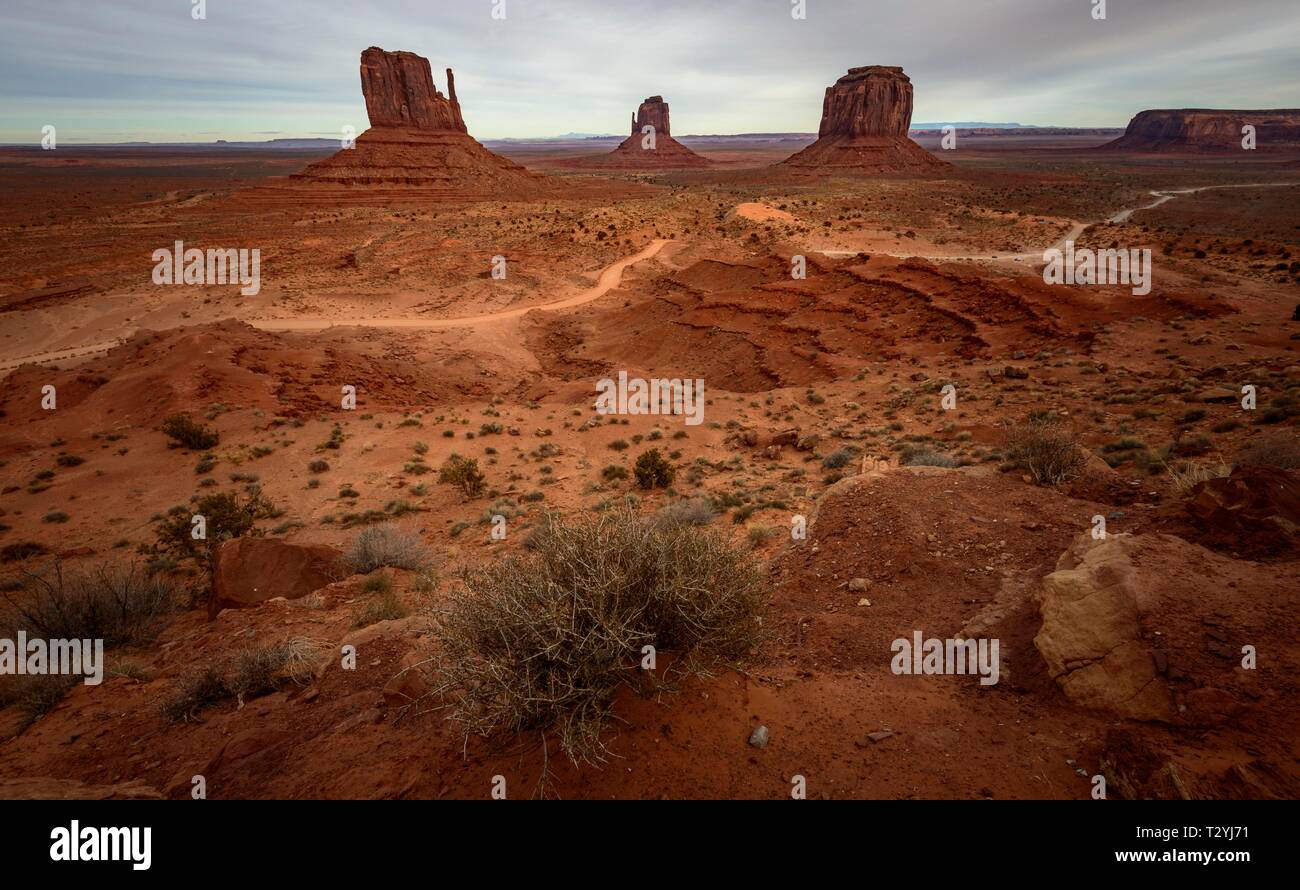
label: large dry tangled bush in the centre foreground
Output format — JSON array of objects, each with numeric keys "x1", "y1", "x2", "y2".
[{"x1": 436, "y1": 507, "x2": 766, "y2": 763}]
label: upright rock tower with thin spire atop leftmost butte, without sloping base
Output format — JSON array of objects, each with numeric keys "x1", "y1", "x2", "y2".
[{"x1": 361, "y1": 47, "x2": 468, "y2": 133}]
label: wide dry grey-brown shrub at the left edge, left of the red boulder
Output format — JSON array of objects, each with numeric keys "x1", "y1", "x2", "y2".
[{"x1": 4, "y1": 559, "x2": 178, "y2": 648}]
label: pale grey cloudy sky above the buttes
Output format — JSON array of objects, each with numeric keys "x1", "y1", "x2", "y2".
[{"x1": 0, "y1": 0, "x2": 1300, "y2": 143}]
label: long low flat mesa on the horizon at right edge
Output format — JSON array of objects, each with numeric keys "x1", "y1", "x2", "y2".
[{"x1": 1101, "y1": 108, "x2": 1300, "y2": 153}]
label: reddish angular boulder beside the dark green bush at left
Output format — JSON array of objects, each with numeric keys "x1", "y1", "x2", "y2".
[{"x1": 208, "y1": 538, "x2": 345, "y2": 618}]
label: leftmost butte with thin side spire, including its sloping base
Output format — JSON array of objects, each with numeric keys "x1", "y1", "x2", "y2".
[{"x1": 293, "y1": 47, "x2": 551, "y2": 200}]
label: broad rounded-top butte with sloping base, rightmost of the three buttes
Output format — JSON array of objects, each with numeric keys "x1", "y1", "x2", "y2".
[{"x1": 781, "y1": 65, "x2": 948, "y2": 173}]
